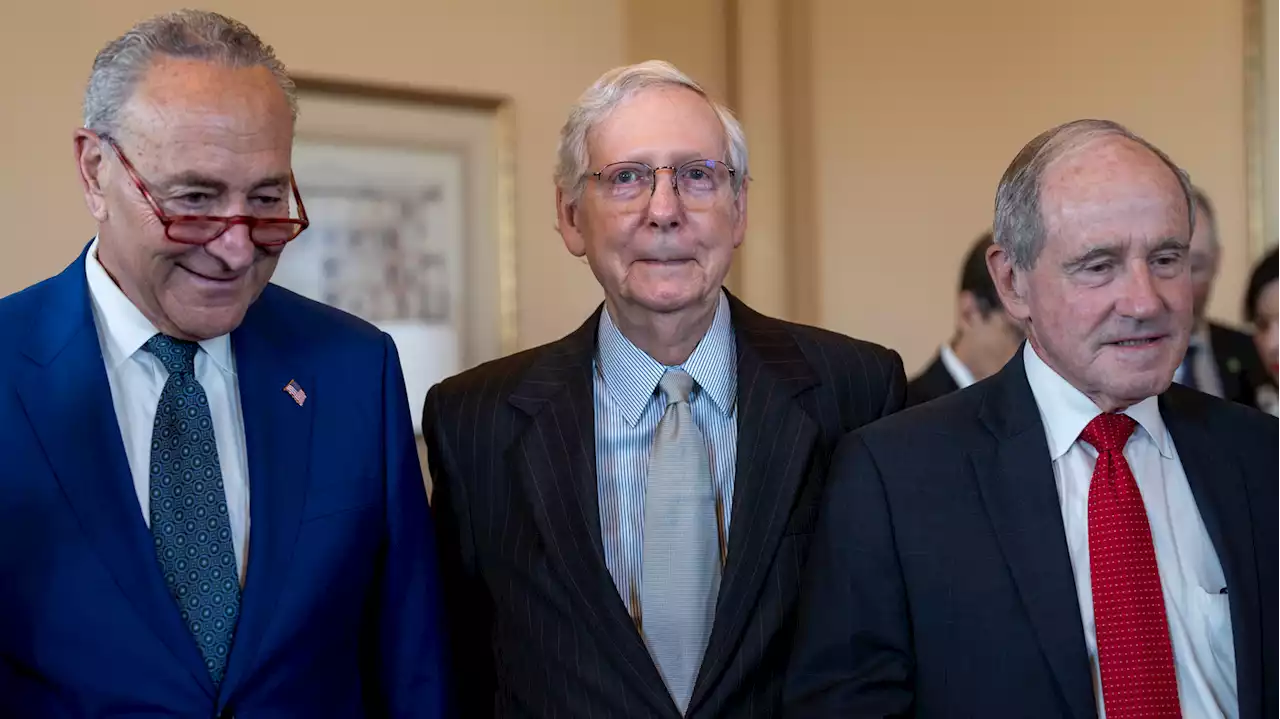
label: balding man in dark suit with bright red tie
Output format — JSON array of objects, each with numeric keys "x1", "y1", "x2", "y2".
[{"x1": 787, "y1": 120, "x2": 1280, "y2": 719}]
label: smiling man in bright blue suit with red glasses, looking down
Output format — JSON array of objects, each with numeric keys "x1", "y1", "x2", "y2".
[{"x1": 0, "y1": 12, "x2": 447, "y2": 718}]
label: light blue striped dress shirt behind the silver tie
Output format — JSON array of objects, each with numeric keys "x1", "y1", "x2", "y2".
[{"x1": 594, "y1": 287, "x2": 737, "y2": 622}]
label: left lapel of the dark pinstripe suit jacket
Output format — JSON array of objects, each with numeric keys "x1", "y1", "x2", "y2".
[{"x1": 507, "y1": 310, "x2": 675, "y2": 714}]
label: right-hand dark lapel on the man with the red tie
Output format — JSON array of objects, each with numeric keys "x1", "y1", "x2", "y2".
[{"x1": 1160, "y1": 386, "x2": 1263, "y2": 718}]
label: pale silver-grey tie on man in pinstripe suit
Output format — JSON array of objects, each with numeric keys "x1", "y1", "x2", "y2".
[{"x1": 640, "y1": 370, "x2": 721, "y2": 714}]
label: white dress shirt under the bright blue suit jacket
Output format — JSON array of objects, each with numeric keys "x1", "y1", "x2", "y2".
[{"x1": 84, "y1": 238, "x2": 250, "y2": 585}]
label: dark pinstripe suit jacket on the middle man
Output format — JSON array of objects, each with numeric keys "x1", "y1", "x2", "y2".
[{"x1": 422, "y1": 297, "x2": 906, "y2": 719}]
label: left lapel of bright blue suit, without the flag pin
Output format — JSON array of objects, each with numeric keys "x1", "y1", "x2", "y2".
[{"x1": 18, "y1": 255, "x2": 214, "y2": 696}]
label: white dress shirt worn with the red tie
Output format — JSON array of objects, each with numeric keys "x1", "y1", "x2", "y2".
[{"x1": 1023, "y1": 343, "x2": 1239, "y2": 718}]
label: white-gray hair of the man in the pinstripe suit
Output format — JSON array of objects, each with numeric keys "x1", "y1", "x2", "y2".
[{"x1": 556, "y1": 60, "x2": 748, "y2": 201}]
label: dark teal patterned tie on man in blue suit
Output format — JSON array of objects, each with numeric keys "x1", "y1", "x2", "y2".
[{"x1": 143, "y1": 334, "x2": 239, "y2": 684}]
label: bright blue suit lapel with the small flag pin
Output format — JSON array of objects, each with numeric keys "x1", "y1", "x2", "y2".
[{"x1": 223, "y1": 287, "x2": 312, "y2": 695}]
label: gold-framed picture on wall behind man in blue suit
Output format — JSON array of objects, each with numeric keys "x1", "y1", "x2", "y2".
[{"x1": 273, "y1": 77, "x2": 517, "y2": 434}]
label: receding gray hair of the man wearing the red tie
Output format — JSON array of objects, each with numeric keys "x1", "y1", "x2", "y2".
[{"x1": 995, "y1": 120, "x2": 1196, "y2": 270}]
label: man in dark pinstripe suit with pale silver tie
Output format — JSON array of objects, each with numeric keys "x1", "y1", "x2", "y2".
[{"x1": 422, "y1": 61, "x2": 905, "y2": 718}]
